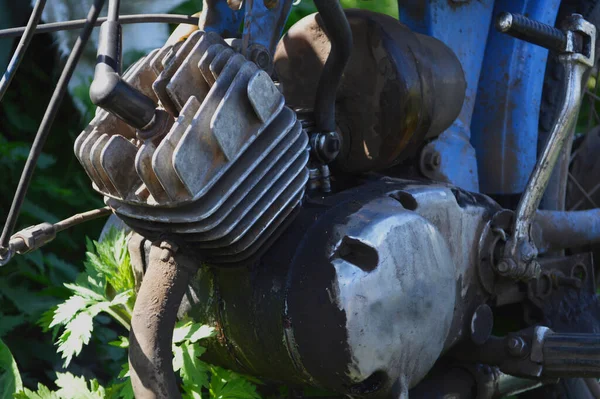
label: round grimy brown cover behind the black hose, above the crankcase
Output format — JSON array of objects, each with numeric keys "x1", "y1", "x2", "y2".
[{"x1": 274, "y1": 10, "x2": 466, "y2": 172}]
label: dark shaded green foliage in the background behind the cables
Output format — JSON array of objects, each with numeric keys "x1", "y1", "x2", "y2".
[{"x1": 0, "y1": 0, "x2": 398, "y2": 398}]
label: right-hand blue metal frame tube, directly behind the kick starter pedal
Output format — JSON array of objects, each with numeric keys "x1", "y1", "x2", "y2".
[{"x1": 471, "y1": 0, "x2": 560, "y2": 195}]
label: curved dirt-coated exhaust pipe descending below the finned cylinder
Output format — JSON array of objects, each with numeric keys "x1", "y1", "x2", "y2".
[{"x1": 129, "y1": 242, "x2": 191, "y2": 399}]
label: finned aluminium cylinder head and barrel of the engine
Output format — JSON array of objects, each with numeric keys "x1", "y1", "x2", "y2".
[{"x1": 75, "y1": 31, "x2": 309, "y2": 263}]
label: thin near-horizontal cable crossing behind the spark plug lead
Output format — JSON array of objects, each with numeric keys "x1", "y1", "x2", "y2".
[{"x1": 0, "y1": 14, "x2": 199, "y2": 39}]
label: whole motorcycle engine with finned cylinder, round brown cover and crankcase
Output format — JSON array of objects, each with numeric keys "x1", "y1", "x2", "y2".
[{"x1": 75, "y1": 10, "x2": 498, "y2": 397}]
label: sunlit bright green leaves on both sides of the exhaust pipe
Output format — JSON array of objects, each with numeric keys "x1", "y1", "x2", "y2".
[{"x1": 24, "y1": 229, "x2": 259, "y2": 399}]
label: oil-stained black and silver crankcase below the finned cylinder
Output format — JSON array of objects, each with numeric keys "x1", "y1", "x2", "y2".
[{"x1": 180, "y1": 178, "x2": 498, "y2": 398}]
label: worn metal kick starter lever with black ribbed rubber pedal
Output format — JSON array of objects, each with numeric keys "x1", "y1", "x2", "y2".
[{"x1": 496, "y1": 12, "x2": 596, "y2": 280}]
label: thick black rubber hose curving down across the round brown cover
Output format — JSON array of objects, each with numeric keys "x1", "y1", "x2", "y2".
[{"x1": 314, "y1": 0, "x2": 352, "y2": 132}]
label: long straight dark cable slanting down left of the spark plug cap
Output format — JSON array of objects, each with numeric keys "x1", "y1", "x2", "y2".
[{"x1": 0, "y1": 0, "x2": 104, "y2": 252}]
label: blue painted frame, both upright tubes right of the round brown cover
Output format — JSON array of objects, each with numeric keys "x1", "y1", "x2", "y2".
[{"x1": 398, "y1": 0, "x2": 560, "y2": 194}]
